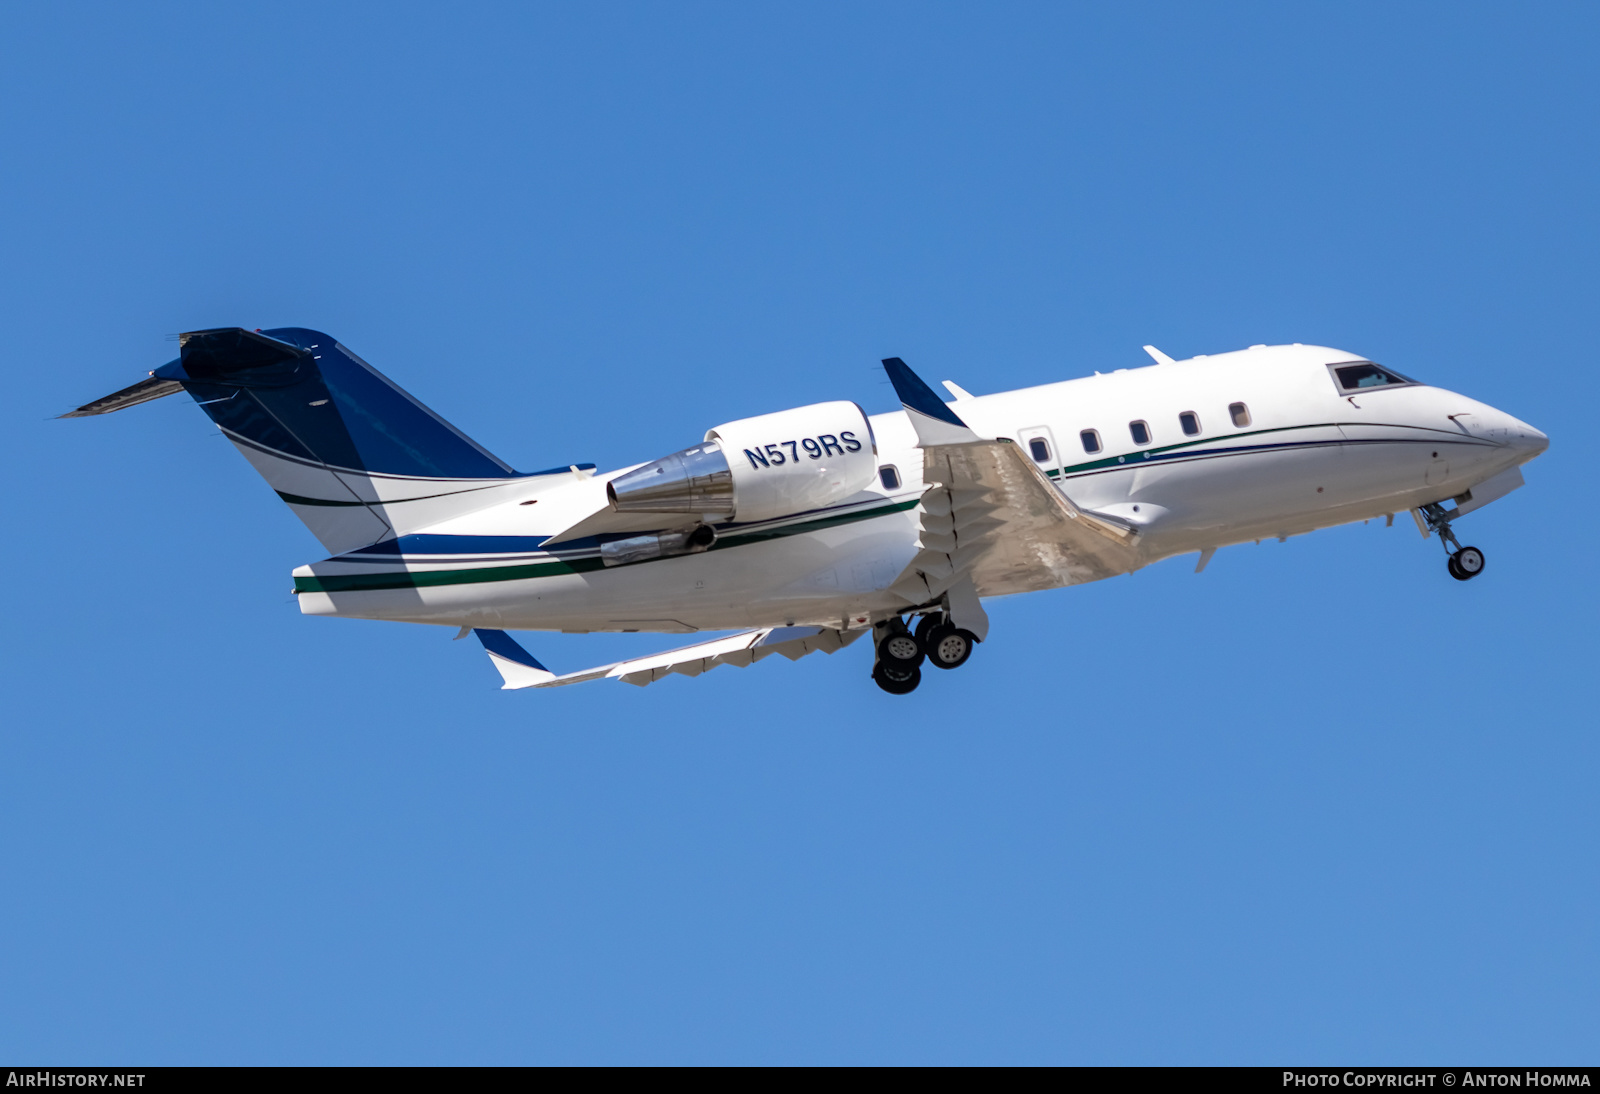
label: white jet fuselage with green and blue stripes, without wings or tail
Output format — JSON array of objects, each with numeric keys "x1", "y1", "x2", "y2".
[{"x1": 296, "y1": 345, "x2": 1547, "y2": 632}]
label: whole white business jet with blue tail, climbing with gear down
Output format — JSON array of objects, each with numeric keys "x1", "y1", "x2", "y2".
[{"x1": 66, "y1": 328, "x2": 1549, "y2": 694}]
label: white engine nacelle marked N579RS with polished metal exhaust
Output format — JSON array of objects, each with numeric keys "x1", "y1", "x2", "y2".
[{"x1": 606, "y1": 401, "x2": 878, "y2": 521}]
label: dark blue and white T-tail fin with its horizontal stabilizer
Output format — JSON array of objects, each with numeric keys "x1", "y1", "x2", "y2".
[{"x1": 67, "y1": 319, "x2": 544, "y2": 553}]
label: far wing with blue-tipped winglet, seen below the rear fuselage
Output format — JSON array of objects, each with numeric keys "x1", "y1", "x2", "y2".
[{"x1": 472, "y1": 627, "x2": 867, "y2": 691}]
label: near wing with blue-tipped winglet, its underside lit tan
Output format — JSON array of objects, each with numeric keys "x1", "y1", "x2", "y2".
[{"x1": 885, "y1": 358, "x2": 1144, "y2": 614}]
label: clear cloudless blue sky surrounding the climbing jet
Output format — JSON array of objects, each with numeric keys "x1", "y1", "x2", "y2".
[{"x1": 0, "y1": 3, "x2": 1600, "y2": 1064}]
